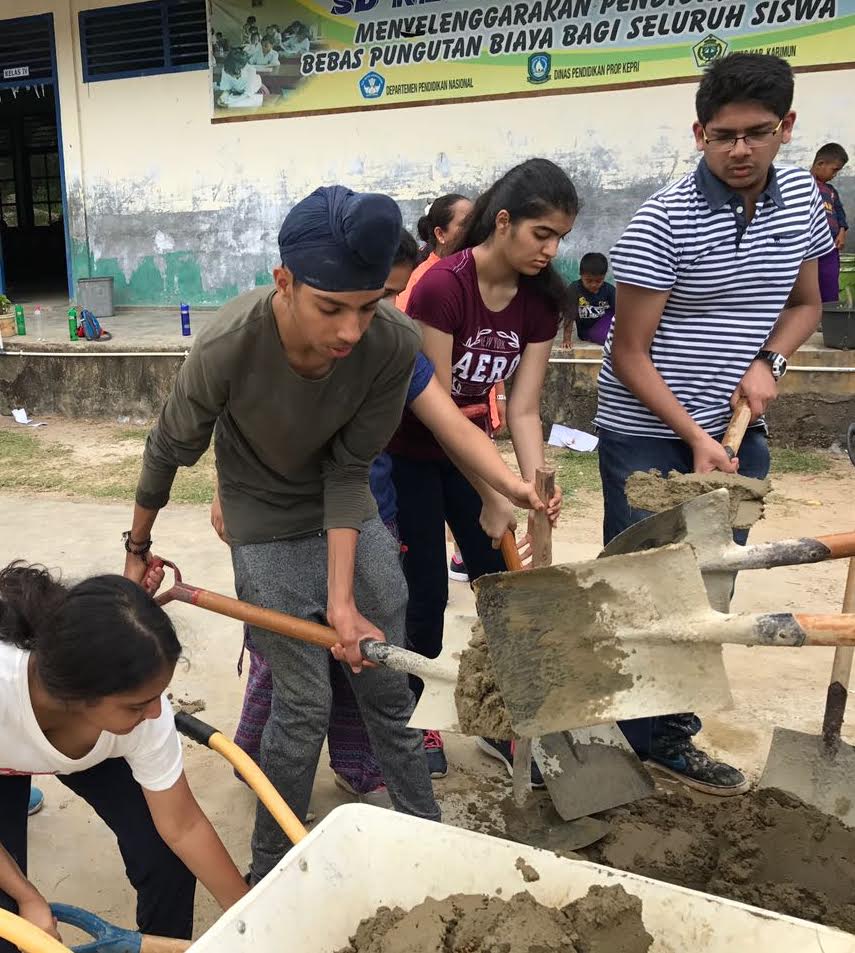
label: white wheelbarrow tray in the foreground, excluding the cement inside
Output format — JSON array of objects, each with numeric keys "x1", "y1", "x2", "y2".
[{"x1": 192, "y1": 805, "x2": 855, "y2": 953}]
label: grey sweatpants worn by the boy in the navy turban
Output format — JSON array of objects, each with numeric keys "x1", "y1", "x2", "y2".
[{"x1": 232, "y1": 519, "x2": 439, "y2": 883}]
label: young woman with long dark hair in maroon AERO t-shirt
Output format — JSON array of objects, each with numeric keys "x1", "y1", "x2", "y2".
[{"x1": 389, "y1": 159, "x2": 578, "y2": 784}]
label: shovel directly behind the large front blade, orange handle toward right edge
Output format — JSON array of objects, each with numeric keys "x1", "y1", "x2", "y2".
[{"x1": 601, "y1": 489, "x2": 855, "y2": 612}]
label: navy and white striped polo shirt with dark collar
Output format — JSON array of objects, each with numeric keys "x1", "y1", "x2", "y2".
[{"x1": 596, "y1": 159, "x2": 833, "y2": 437}]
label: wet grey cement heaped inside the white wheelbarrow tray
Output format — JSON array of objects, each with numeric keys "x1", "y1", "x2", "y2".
[{"x1": 339, "y1": 884, "x2": 653, "y2": 953}]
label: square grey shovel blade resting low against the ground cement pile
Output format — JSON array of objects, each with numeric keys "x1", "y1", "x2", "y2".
[{"x1": 533, "y1": 724, "x2": 655, "y2": 821}]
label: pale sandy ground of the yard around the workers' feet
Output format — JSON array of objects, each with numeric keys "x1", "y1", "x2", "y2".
[{"x1": 0, "y1": 419, "x2": 855, "y2": 932}]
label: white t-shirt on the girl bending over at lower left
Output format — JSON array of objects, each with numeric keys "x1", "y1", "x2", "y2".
[{"x1": 0, "y1": 642, "x2": 184, "y2": 791}]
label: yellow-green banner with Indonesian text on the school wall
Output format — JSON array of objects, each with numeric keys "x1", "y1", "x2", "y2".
[{"x1": 211, "y1": 0, "x2": 855, "y2": 120}]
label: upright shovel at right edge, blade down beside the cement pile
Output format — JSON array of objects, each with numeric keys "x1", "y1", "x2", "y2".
[{"x1": 760, "y1": 559, "x2": 855, "y2": 827}]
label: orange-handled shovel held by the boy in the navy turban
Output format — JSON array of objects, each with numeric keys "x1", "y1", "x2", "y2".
[{"x1": 152, "y1": 559, "x2": 459, "y2": 731}]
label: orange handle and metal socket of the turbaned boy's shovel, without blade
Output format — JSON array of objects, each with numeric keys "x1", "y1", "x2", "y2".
[{"x1": 155, "y1": 556, "x2": 448, "y2": 681}]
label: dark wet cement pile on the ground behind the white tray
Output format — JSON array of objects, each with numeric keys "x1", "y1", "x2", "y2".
[{"x1": 582, "y1": 790, "x2": 855, "y2": 933}]
